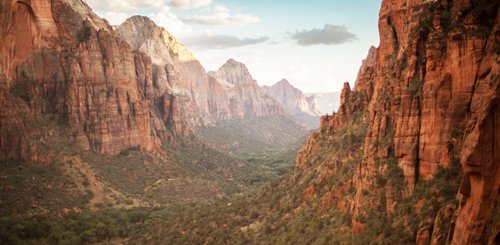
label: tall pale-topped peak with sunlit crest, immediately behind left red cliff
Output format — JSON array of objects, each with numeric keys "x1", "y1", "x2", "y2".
[{"x1": 115, "y1": 16, "x2": 209, "y2": 127}]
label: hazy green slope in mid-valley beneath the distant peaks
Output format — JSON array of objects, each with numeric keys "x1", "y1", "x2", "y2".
[{"x1": 195, "y1": 115, "x2": 308, "y2": 186}]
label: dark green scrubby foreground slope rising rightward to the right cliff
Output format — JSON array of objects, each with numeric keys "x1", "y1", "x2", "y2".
[{"x1": 0, "y1": 96, "x2": 460, "y2": 244}]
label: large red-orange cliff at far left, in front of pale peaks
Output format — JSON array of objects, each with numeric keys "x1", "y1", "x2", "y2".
[{"x1": 0, "y1": 0, "x2": 186, "y2": 157}]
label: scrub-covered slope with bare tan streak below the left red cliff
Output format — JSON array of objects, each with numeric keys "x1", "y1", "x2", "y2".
[{"x1": 0, "y1": 111, "x2": 302, "y2": 216}]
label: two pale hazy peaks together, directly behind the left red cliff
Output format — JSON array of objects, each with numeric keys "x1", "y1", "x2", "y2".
[{"x1": 116, "y1": 16, "x2": 283, "y2": 126}]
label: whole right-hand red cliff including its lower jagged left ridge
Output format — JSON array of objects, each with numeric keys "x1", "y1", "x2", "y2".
[{"x1": 297, "y1": 0, "x2": 500, "y2": 244}]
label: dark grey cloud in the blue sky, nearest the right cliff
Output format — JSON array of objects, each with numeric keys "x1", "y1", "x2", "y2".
[{"x1": 288, "y1": 24, "x2": 358, "y2": 46}]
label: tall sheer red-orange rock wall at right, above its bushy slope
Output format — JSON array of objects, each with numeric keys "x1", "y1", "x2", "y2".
[{"x1": 358, "y1": 1, "x2": 500, "y2": 244}]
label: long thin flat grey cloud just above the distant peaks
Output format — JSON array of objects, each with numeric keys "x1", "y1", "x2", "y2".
[{"x1": 182, "y1": 35, "x2": 269, "y2": 49}]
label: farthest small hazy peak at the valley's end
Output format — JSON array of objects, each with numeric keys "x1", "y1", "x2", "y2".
[{"x1": 263, "y1": 79, "x2": 321, "y2": 117}]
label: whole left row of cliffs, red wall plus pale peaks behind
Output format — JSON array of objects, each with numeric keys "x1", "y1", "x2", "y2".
[{"x1": 0, "y1": 0, "x2": 283, "y2": 158}]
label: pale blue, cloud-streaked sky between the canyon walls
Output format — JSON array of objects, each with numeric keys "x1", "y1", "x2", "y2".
[{"x1": 86, "y1": 0, "x2": 382, "y2": 92}]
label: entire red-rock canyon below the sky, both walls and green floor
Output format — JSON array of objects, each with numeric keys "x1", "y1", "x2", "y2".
[{"x1": 0, "y1": 0, "x2": 500, "y2": 244}]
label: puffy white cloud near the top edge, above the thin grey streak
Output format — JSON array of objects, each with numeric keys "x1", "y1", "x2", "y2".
[{"x1": 183, "y1": 6, "x2": 260, "y2": 25}]
